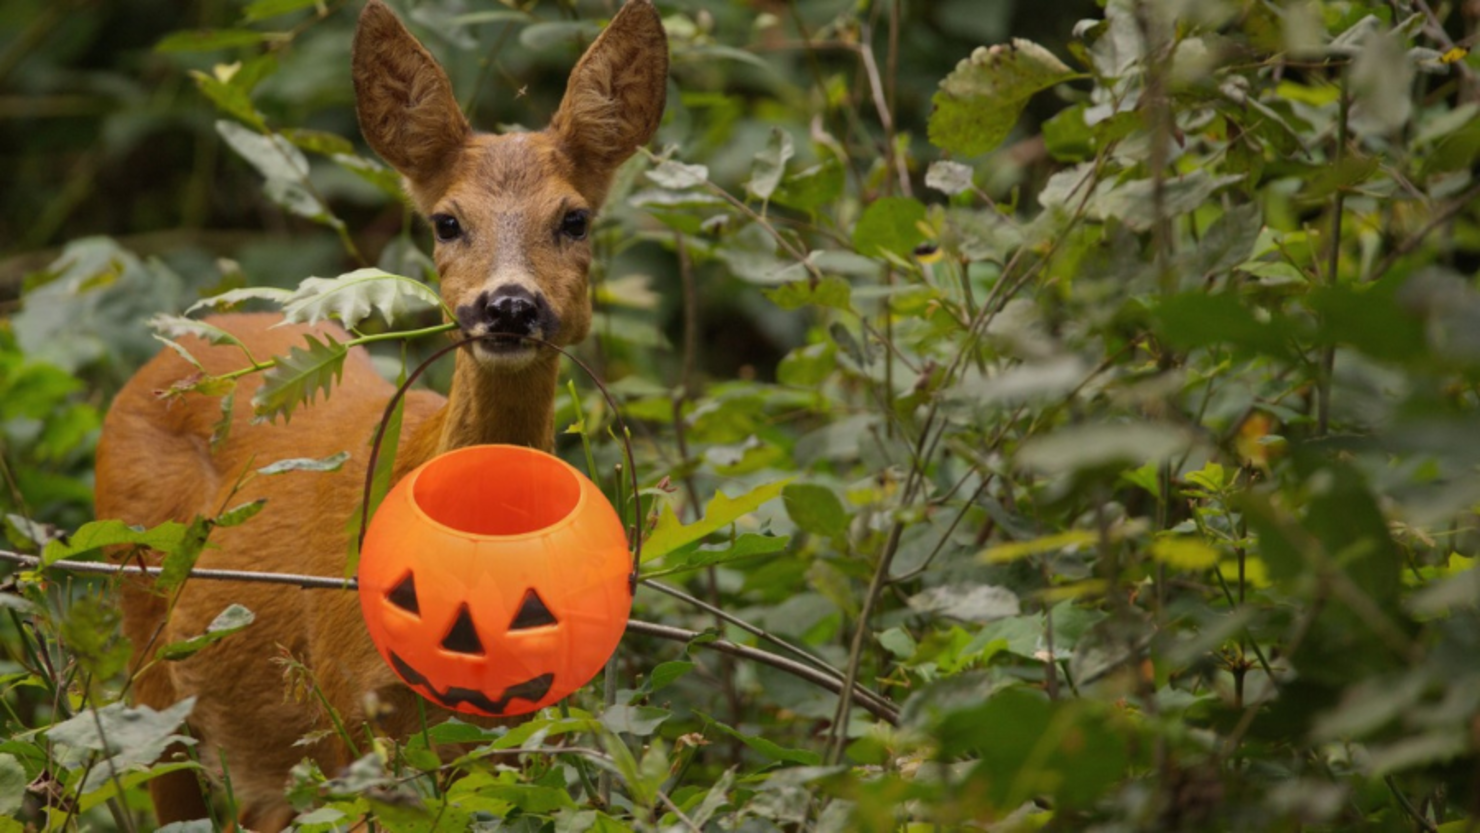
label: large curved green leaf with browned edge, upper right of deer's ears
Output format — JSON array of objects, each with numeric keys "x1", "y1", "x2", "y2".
[{"x1": 929, "y1": 38, "x2": 1074, "y2": 157}]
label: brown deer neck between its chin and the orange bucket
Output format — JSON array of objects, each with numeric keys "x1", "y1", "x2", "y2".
[{"x1": 407, "y1": 351, "x2": 559, "y2": 462}]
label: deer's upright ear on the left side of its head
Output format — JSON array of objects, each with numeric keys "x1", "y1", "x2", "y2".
[{"x1": 354, "y1": 0, "x2": 472, "y2": 186}]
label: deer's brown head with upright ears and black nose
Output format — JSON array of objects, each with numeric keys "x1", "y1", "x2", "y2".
[{"x1": 354, "y1": 0, "x2": 667, "y2": 373}]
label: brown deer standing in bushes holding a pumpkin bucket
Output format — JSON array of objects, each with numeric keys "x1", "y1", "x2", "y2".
[{"x1": 95, "y1": 0, "x2": 669, "y2": 830}]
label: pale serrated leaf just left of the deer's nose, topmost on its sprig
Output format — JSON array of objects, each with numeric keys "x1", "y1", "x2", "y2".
[{"x1": 283, "y1": 268, "x2": 441, "y2": 330}]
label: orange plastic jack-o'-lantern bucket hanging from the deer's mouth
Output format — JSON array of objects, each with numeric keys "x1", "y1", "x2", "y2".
[{"x1": 360, "y1": 445, "x2": 632, "y2": 716}]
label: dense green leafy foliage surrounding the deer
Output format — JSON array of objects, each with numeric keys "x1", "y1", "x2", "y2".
[{"x1": 0, "y1": 0, "x2": 1480, "y2": 830}]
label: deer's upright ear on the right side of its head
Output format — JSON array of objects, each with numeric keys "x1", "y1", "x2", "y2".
[{"x1": 549, "y1": 0, "x2": 667, "y2": 194}]
